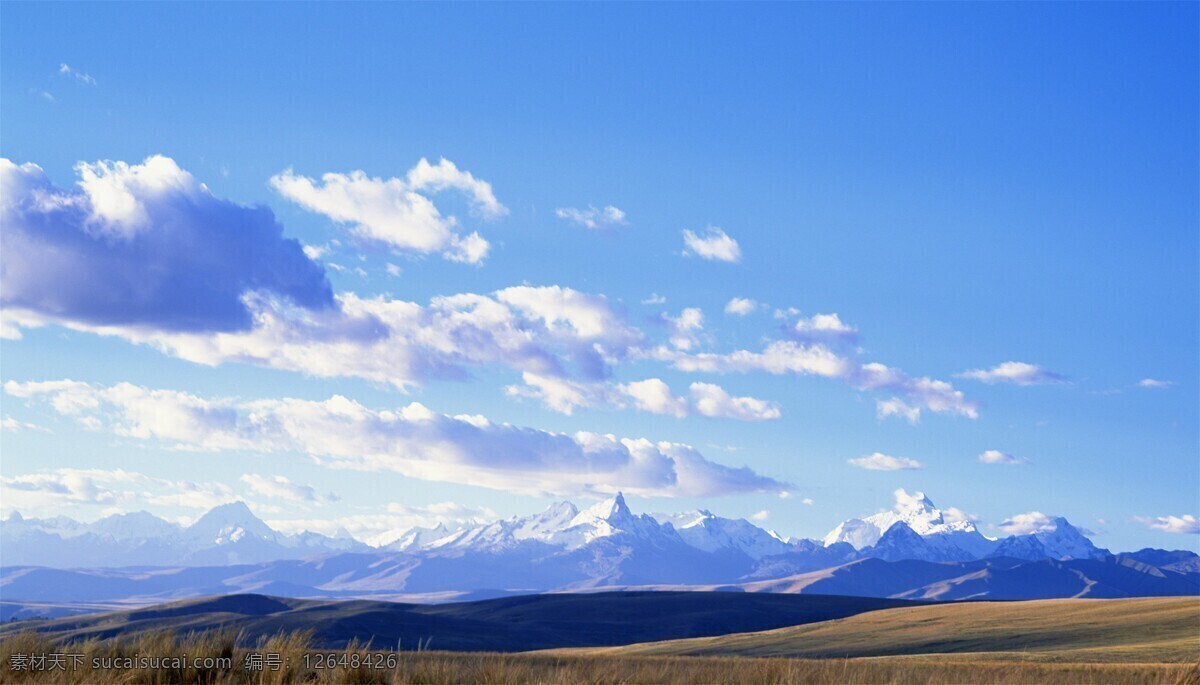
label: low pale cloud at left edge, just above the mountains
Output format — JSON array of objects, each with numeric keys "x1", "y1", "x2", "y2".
[{"x1": 0, "y1": 468, "x2": 235, "y2": 511}]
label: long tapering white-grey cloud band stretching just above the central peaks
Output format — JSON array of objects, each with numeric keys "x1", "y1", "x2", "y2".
[{"x1": 5, "y1": 381, "x2": 787, "y2": 497}]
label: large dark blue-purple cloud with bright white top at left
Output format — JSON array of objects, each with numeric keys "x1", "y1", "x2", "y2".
[{"x1": 0, "y1": 156, "x2": 335, "y2": 331}]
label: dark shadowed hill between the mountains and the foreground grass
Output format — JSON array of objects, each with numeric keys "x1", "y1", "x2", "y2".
[{"x1": 0, "y1": 591, "x2": 920, "y2": 651}]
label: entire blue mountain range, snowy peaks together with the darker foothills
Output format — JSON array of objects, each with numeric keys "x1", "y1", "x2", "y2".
[{"x1": 0, "y1": 491, "x2": 1200, "y2": 602}]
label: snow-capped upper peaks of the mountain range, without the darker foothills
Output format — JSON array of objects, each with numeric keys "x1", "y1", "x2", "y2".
[{"x1": 0, "y1": 489, "x2": 1132, "y2": 577}]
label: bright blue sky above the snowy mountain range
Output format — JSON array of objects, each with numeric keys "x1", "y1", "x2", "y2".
[{"x1": 0, "y1": 4, "x2": 1200, "y2": 549}]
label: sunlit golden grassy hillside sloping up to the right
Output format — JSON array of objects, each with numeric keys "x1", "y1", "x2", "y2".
[{"x1": 566, "y1": 597, "x2": 1200, "y2": 663}]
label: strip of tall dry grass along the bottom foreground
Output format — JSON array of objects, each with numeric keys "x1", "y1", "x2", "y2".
[{"x1": 0, "y1": 632, "x2": 1200, "y2": 685}]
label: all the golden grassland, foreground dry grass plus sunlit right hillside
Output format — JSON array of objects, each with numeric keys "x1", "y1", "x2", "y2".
[{"x1": 0, "y1": 597, "x2": 1200, "y2": 685}]
